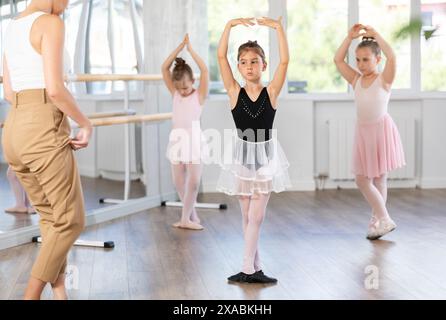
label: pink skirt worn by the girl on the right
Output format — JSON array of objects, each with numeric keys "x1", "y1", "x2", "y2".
[{"x1": 353, "y1": 113, "x2": 406, "y2": 179}]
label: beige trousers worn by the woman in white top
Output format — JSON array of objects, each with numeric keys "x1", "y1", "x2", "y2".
[{"x1": 2, "y1": 89, "x2": 85, "y2": 283}]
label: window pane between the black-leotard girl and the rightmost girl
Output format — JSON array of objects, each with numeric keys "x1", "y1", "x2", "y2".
[{"x1": 287, "y1": 0, "x2": 348, "y2": 93}]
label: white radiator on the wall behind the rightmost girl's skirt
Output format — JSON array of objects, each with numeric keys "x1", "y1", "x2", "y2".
[{"x1": 328, "y1": 117, "x2": 416, "y2": 180}]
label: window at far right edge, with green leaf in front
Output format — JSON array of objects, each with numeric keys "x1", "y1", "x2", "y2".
[{"x1": 421, "y1": 0, "x2": 446, "y2": 91}]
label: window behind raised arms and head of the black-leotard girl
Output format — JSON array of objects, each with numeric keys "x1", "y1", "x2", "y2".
[{"x1": 208, "y1": 0, "x2": 269, "y2": 93}]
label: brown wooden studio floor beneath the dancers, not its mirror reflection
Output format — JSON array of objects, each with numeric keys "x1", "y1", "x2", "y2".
[{"x1": 0, "y1": 190, "x2": 446, "y2": 299}]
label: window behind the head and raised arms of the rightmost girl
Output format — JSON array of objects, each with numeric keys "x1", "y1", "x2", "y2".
[{"x1": 359, "y1": 0, "x2": 411, "y2": 89}]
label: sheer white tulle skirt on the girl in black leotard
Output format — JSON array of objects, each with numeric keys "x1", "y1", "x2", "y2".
[{"x1": 217, "y1": 134, "x2": 291, "y2": 196}]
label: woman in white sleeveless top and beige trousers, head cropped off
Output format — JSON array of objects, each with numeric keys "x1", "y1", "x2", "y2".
[{"x1": 2, "y1": 0, "x2": 92, "y2": 299}]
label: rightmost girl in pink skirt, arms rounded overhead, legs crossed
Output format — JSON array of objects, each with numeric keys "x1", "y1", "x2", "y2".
[{"x1": 334, "y1": 24, "x2": 406, "y2": 240}]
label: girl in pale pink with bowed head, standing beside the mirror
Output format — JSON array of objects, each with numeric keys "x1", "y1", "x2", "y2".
[{"x1": 161, "y1": 34, "x2": 209, "y2": 230}]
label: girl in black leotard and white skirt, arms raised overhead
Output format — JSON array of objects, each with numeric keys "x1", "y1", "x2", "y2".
[{"x1": 217, "y1": 18, "x2": 290, "y2": 283}]
